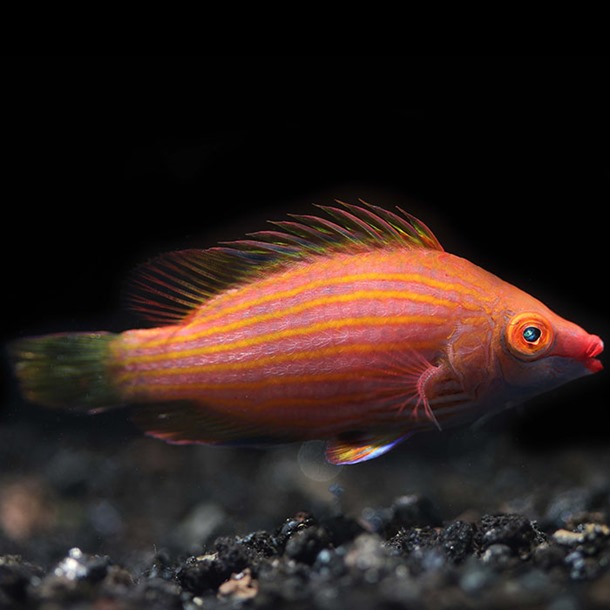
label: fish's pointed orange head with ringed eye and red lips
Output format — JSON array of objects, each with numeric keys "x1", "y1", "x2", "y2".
[{"x1": 498, "y1": 301, "x2": 604, "y2": 399}]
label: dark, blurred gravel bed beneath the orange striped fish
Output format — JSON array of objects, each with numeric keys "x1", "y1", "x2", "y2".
[{"x1": 0, "y1": 404, "x2": 610, "y2": 610}]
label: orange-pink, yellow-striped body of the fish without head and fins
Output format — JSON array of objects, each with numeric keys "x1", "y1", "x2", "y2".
[{"x1": 113, "y1": 249, "x2": 484, "y2": 434}]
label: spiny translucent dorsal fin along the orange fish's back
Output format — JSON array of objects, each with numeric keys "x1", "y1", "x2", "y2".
[{"x1": 129, "y1": 201, "x2": 443, "y2": 324}]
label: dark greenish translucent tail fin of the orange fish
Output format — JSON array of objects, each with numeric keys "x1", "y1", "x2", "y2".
[{"x1": 9, "y1": 332, "x2": 121, "y2": 411}]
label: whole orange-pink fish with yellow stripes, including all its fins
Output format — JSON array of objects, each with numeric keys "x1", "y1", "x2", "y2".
[{"x1": 9, "y1": 200, "x2": 604, "y2": 464}]
